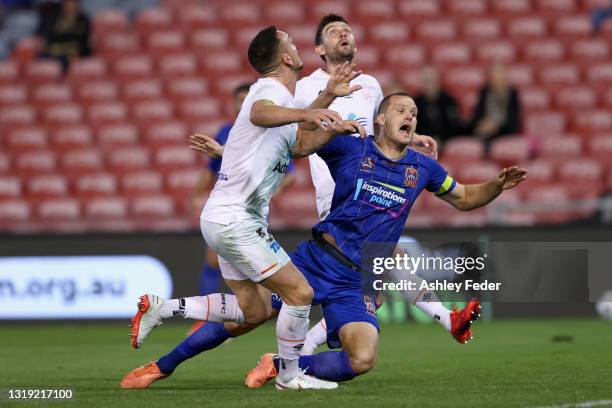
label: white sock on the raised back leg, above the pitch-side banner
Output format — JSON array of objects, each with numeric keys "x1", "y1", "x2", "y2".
[{"x1": 160, "y1": 293, "x2": 244, "y2": 323}]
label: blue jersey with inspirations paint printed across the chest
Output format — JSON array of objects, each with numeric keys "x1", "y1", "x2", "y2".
[{"x1": 314, "y1": 136, "x2": 456, "y2": 265}]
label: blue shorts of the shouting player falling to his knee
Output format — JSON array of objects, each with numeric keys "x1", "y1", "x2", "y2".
[{"x1": 272, "y1": 241, "x2": 379, "y2": 348}]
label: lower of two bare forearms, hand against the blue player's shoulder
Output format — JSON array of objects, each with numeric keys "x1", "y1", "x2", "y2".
[{"x1": 292, "y1": 120, "x2": 367, "y2": 158}]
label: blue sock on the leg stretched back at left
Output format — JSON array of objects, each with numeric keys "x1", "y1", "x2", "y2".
[{"x1": 157, "y1": 322, "x2": 232, "y2": 374}]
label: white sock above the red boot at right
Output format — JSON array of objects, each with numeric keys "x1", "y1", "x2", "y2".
[{"x1": 390, "y1": 269, "x2": 451, "y2": 331}]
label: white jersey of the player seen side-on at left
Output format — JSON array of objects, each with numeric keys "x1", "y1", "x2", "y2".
[{"x1": 200, "y1": 78, "x2": 297, "y2": 225}]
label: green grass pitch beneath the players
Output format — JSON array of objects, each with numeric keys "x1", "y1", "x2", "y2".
[{"x1": 0, "y1": 319, "x2": 612, "y2": 408}]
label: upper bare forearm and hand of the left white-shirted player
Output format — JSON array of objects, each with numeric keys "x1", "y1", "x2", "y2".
[{"x1": 251, "y1": 99, "x2": 342, "y2": 130}]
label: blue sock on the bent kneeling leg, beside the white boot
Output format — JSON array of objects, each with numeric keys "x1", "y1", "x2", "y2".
[{"x1": 274, "y1": 351, "x2": 357, "y2": 381}]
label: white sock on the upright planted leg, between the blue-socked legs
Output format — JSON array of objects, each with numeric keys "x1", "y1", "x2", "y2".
[{"x1": 276, "y1": 303, "x2": 310, "y2": 383}]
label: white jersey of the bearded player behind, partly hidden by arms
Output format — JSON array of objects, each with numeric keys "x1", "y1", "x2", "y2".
[{"x1": 295, "y1": 68, "x2": 383, "y2": 219}]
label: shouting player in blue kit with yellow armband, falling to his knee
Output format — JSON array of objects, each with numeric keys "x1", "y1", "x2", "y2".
[{"x1": 119, "y1": 93, "x2": 526, "y2": 388}]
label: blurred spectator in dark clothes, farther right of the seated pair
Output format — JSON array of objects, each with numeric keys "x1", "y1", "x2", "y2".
[{"x1": 468, "y1": 63, "x2": 521, "y2": 149}]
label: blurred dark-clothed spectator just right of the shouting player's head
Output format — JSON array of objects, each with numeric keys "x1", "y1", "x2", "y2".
[{"x1": 414, "y1": 66, "x2": 464, "y2": 143}]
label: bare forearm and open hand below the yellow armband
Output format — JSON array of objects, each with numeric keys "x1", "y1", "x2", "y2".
[{"x1": 440, "y1": 166, "x2": 527, "y2": 211}]
